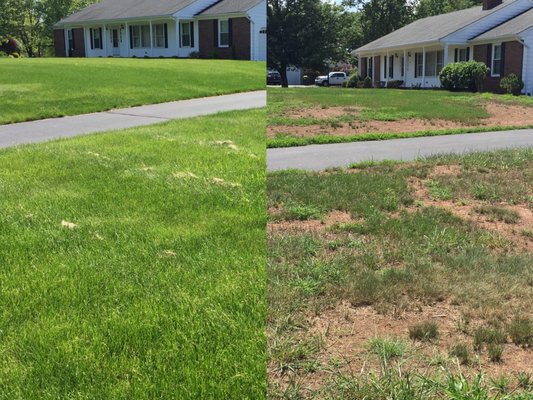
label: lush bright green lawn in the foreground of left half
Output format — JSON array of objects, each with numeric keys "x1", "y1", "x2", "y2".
[{"x1": 0, "y1": 108, "x2": 266, "y2": 400}]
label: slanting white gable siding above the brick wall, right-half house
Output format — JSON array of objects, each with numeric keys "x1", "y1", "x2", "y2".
[{"x1": 442, "y1": 0, "x2": 533, "y2": 43}]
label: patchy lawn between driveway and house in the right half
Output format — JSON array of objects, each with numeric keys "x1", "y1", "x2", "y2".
[{"x1": 267, "y1": 87, "x2": 533, "y2": 147}]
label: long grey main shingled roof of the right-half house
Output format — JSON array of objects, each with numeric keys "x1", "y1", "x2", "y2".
[{"x1": 356, "y1": 0, "x2": 514, "y2": 52}]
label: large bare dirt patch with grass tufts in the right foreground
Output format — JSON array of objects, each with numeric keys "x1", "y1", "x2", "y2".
[{"x1": 278, "y1": 302, "x2": 533, "y2": 388}]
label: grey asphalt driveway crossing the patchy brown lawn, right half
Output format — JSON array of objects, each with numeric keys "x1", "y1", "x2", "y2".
[{"x1": 267, "y1": 129, "x2": 533, "y2": 171}]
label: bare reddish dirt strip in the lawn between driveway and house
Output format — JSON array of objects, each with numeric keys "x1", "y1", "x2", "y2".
[{"x1": 267, "y1": 102, "x2": 533, "y2": 138}]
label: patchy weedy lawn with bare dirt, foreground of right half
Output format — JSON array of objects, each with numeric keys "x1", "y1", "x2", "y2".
[{"x1": 267, "y1": 149, "x2": 533, "y2": 400}]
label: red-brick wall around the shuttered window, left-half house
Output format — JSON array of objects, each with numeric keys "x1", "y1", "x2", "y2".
[{"x1": 199, "y1": 17, "x2": 251, "y2": 60}]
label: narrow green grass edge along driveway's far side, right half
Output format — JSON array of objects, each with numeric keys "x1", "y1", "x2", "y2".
[{"x1": 267, "y1": 125, "x2": 533, "y2": 149}]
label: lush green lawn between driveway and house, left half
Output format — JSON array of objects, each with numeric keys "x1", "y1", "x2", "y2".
[{"x1": 0, "y1": 58, "x2": 265, "y2": 124}]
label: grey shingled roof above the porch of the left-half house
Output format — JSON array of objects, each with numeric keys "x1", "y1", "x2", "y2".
[{"x1": 57, "y1": 0, "x2": 195, "y2": 25}]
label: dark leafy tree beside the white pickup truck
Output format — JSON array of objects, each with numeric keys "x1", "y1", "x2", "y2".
[{"x1": 267, "y1": 0, "x2": 345, "y2": 87}]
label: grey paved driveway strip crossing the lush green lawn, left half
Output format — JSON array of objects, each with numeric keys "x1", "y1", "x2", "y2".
[{"x1": 0, "y1": 91, "x2": 266, "y2": 148}]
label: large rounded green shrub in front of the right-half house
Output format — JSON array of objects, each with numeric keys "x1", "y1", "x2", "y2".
[{"x1": 439, "y1": 61, "x2": 489, "y2": 92}]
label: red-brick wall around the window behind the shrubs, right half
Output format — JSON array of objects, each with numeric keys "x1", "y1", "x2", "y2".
[{"x1": 474, "y1": 41, "x2": 524, "y2": 93}]
